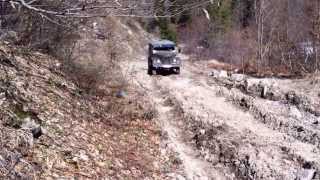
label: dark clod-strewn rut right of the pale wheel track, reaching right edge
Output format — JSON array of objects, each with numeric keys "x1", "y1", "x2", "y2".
[{"x1": 229, "y1": 88, "x2": 320, "y2": 148}]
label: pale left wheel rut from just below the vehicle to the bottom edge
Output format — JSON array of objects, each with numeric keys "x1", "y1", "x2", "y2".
[{"x1": 150, "y1": 79, "x2": 230, "y2": 180}]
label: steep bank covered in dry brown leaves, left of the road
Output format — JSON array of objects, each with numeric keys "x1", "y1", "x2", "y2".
[{"x1": 0, "y1": 44, "x2": 165, "y2": 179}]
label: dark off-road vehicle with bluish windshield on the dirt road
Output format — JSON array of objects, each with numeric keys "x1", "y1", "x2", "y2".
[{"x1": 148, "y1": 40, "x2": 181, "y2": 75}]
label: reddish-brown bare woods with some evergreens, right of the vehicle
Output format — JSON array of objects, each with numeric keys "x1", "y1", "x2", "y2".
[{"x1": 144, "y1": 0, "x2": 320, "y2": 75}]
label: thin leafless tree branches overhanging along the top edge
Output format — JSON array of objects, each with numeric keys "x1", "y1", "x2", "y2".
[{"x1": 2, "y1": 0, "x2": 211, "y2": 18}]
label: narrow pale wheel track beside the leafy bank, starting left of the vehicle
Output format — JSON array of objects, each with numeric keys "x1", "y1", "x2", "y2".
[{"x1": 121, "y1": 58, "x2": 226, "y2": 180}]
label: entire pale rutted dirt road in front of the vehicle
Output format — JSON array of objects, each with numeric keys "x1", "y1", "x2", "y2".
[{"x1": 124, "y1": 57, "x2": 320, "y2": 180}]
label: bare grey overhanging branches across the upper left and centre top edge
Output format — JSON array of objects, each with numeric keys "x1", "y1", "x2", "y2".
[{"x1": 2, "y1": 0, "x2": 212, "y2": 18}]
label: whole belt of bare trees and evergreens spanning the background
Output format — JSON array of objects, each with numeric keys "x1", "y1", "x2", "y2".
[{"x1": 0, "y1": 0, "x2": 320, "y2": 74}]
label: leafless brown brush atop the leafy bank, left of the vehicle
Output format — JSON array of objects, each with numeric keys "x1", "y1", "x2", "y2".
[{"x1": 60, "y1": 19, "x2": 126, "y2": 96}]
